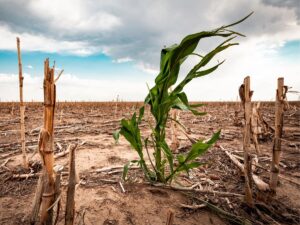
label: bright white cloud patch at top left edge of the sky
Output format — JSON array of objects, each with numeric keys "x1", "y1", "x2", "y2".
[{"x1": 28, "y1": 0, "x2": 122, "y2": 34}]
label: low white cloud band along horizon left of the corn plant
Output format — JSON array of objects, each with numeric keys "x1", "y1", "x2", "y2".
[{"x1": 0, "y1": 74, "x2": 152, "y2": 101}]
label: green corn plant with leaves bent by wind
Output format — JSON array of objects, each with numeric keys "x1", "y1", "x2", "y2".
[{"x1": 114, "y1": 13, "x2": 252, "y2": 183}]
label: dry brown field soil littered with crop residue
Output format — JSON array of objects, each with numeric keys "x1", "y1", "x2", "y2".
[{"x1": 0, "y1": 102, "x2": 300, "y2": 225}]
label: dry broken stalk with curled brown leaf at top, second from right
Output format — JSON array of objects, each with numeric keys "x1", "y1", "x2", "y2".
[{"x1": 239, "y1": 76, "x2": 254, "y2": 207}]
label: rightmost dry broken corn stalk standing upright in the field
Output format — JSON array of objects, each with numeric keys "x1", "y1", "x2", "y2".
[{"x1": 270, "y1": 77, "x2": 287, "y2": 192}]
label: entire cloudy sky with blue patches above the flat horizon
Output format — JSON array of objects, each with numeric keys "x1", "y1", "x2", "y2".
[{"x1": 0, "y1": 0, "x2": 300, "y2": 101}]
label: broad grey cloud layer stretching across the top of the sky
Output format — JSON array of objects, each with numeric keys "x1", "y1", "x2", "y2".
[{"x1": 0, "y1": 0, "x2": 300, "y2": 62}]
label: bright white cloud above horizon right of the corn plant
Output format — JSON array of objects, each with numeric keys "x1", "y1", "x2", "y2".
[{"x1": 186, "y1": 37, "x2": 300, "y2": 101}]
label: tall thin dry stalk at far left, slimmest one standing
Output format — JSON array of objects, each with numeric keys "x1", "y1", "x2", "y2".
[{"x1": 17, "y1": 37, "x2": 28, "y2": 169}]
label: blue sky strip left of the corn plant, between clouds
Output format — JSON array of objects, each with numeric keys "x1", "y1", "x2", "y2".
[{"x1": 0, "y1": 51, "x2": 149, "y2": 80}]
